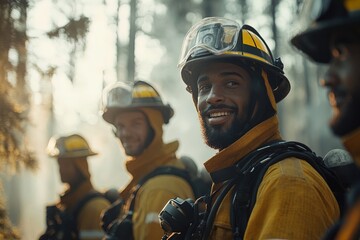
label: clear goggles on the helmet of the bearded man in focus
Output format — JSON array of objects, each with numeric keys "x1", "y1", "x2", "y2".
[{"x1": 178, "y1": 17, "x2": 241, "y2": 68}]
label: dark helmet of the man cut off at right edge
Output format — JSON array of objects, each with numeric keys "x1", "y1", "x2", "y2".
[{"x1": 291, "y1": 0, "x2": 360, "y2": 63}]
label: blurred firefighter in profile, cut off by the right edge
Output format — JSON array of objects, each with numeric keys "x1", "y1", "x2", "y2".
[{"x1": 291, "y1": 0, "x2": 360, "y2": 239}]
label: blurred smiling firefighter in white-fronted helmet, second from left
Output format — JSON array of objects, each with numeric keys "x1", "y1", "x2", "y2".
[{"x1": 102, "y1": 81, "x2": 194, "y2": 240}]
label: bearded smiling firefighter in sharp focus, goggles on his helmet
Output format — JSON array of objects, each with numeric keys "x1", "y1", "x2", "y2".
[{"x1": 166, "y1": 17, "x2": 339, "y2": 240}]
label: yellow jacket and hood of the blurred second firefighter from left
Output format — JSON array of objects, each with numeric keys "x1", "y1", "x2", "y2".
[{"x1": 120, "y1": 108, "x2": 194, "y2": 240}]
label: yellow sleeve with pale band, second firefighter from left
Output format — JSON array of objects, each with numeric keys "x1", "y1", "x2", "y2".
[{"x1": 133, "y1": 175, "x2": 194, "y2": 240}]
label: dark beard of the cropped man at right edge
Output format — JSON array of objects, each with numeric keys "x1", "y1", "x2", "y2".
[{"x1": 330, "y1": 96, "x2": 360, "y2": 136}]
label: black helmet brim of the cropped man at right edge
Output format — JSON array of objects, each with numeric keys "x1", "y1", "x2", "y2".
[{"x1": 290, "y1": 11, "x2": 360, "y2": 63}]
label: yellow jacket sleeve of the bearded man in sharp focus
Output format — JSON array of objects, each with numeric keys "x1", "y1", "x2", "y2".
[{"x1": 245, "y1": 159, "x2": 339, "y2": 240}]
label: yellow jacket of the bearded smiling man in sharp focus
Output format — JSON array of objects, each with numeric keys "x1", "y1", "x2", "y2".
[{"x1": 205, "y1": 116, "x2": 339, "y2": 240}]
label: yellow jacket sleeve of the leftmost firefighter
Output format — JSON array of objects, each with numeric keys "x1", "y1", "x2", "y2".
[{"x1": 77, "y1": 197, "x2": 110, "y2": 240}]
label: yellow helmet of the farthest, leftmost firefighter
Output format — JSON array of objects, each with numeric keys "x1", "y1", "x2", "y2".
[{"x1": 47, "y1": 134, "x2": 97, "y2": 158}]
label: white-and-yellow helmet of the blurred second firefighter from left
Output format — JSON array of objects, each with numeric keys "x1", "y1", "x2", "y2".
[{"x1": 102, "y1": 81, "x2": 174, "y2": 124}]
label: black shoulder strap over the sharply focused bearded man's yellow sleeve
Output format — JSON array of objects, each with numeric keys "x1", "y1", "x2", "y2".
[{"x1": 230, "y1": 142, "x2": 345, "y2": 239}]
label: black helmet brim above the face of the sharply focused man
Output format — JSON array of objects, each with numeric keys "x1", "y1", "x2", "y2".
[{"x1": 181, "y1": 54, "x2": 291, "y2": 102}]
